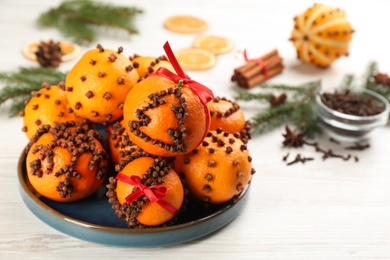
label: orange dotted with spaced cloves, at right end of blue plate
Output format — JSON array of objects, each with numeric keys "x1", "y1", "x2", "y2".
[{"x1": 174, "y1": 128, "x2": 254, "y2": 204}]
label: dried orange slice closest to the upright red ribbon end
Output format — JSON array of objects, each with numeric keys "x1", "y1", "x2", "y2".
[{"x1": 175, "y1": 48, "x2": 217, "y2": 70}]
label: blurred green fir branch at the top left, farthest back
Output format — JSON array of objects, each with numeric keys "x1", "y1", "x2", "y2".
[{"x1": 37, "y1": 0, "x2": 142, "y2": 44}]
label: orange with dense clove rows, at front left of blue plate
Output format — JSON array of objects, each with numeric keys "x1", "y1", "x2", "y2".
[{"x1": 26, "y1": 121, "x2": 108, "y2": 202}]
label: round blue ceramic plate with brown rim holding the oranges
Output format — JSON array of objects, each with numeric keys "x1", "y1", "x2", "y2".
[{"x1": 18, "y1": 149, "x2": 249, "y2": 247}]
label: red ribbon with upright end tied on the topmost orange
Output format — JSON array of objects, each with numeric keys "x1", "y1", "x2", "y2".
[{"x1": 149, "y1": 42, "x2": 214, "y2": 139}]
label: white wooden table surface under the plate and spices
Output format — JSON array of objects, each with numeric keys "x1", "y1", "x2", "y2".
[{"x1": 0, "y1": 0, "x2": 390, "y2": 259}]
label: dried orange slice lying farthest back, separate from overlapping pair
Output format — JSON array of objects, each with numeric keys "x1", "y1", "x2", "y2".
[{"x1": 164, "y1": 15, "x2": 209, "y2": 33}]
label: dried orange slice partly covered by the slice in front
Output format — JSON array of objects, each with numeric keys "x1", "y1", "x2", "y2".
[{"x1": 193, "y1": 34, "x2": 234, "y2": 55}]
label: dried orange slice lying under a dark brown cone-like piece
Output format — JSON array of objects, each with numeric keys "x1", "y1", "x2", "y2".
[{"x1": 22, "y1": 41, "x2": 80, "y2": 61}]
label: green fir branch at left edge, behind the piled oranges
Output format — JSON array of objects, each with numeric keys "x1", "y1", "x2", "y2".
[{"x1": 0, "y1": 67, "x2": 66, "y2": 116}]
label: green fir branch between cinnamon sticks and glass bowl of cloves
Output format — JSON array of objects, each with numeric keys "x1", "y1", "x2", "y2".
[{"x1": 235, "y1": 81, "x2": 321, "y2": 137}]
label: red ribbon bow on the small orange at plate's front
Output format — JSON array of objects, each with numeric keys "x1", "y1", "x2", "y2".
[{"x1": 116, "y1": 173, "x2": 178, "y2": 215}]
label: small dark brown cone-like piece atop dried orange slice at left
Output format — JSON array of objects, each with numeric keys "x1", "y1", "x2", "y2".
[{"x1": 35, "y1": 40, "x2": 63, "y2": 68}]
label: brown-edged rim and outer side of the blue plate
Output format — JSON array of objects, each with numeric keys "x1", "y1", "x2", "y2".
[{"x1": 17, "y1": 149, "x2": 251, "y2": 247}]
